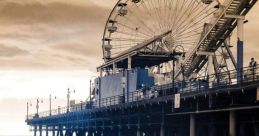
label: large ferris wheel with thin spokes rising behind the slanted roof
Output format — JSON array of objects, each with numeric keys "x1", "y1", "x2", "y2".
[{"x1": 102, "y1": 0, "x2": 227, "y2": 61}]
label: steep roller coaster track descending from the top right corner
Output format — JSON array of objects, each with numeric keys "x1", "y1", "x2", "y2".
[{"x1": 175, "y1": 0, "x2": 257, "y2": 77}]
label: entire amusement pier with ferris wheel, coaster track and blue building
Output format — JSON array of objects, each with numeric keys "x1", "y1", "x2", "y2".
[{"x1": 26, "y1": 0, "x2": 259, "y2": 136}]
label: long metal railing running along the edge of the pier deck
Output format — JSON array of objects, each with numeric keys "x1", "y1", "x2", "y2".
[{"x1": 28, "y1": 65, "x2": 259, "y2": 120}]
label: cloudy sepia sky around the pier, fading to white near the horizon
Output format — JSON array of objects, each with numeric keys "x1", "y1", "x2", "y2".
[{"x1": 0, "y1": 0, "x2": 259, "y2": 136}]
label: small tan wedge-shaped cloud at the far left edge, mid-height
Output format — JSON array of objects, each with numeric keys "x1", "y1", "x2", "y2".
[{"x1": 0, "y1": 44, "x2": 30, "y2": 57}]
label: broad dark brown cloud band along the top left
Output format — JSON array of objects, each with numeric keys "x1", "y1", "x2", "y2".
[{"x1": 0, "y1": 1, "x2": 109, "y2": 24}]
